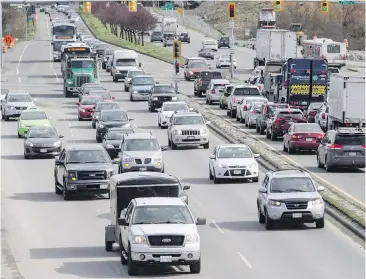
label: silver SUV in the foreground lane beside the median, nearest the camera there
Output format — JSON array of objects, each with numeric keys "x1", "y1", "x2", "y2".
[{"x1": 257, "y1": 170, "x2": 325, "y2": 230}]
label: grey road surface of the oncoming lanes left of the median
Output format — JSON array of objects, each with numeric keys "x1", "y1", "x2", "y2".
[{"x1": 1, "y1": 14, "x2": 365, "y2": 279}]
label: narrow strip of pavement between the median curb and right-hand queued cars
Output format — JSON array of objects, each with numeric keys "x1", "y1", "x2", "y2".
[{"x1": 199, "y1": 101, "x2": 365, "y2": 203}]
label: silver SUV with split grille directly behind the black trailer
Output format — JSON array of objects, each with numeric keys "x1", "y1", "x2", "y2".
[{"x1": 118, "y1": 133, "x2": 167, "y2": 173}]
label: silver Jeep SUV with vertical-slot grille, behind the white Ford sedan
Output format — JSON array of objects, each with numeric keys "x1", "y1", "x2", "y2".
[{"x1": 168, "y1": 111, "x2": 210, "y2": 149}]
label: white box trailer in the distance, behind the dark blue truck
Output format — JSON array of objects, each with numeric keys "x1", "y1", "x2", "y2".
[{"x1": 254, "y1": 29, "x2": 297, "y2": 69}]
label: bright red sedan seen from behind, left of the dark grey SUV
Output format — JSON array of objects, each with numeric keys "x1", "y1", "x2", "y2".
[{"x1": 283, "y1": 123, "x2": 324, "y2": 154}]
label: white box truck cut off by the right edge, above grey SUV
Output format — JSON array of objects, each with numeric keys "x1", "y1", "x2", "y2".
[{"x1": 327, "y1": 74, "x2": 365, "y2": 129}]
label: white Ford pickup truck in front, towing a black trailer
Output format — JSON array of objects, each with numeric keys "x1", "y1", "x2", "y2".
[{"x1": 118, "y1": 198, "x2": 206, "y2": 275}]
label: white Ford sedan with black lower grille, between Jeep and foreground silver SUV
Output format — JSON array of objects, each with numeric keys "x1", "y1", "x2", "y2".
[{"x1": 209, "y1": 144, "x2": 259, "y2": 184}]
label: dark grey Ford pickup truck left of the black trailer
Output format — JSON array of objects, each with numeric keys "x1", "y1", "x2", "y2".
[{"x1": 54, "y1": 144, "x2": 114, "y2": 200}]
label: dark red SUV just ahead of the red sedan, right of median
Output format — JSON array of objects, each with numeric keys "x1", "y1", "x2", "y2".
[{"x1": 266, "y1": 109, "x2": 307, "y2": 141}]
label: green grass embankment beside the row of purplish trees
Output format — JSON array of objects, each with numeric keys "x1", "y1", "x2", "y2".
[{"x1": 79, "y1": 12, "x2": 184, "y2": 65}]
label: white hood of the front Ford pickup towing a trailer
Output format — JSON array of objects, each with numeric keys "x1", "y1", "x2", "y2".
[{"x1": 131, "y1": 224, "x2": 197, "y2": 235}]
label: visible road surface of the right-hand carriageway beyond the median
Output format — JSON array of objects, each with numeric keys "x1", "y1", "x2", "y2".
[{"x1": 149, "y1": 11, "x2": 365, "y2": 203}]
